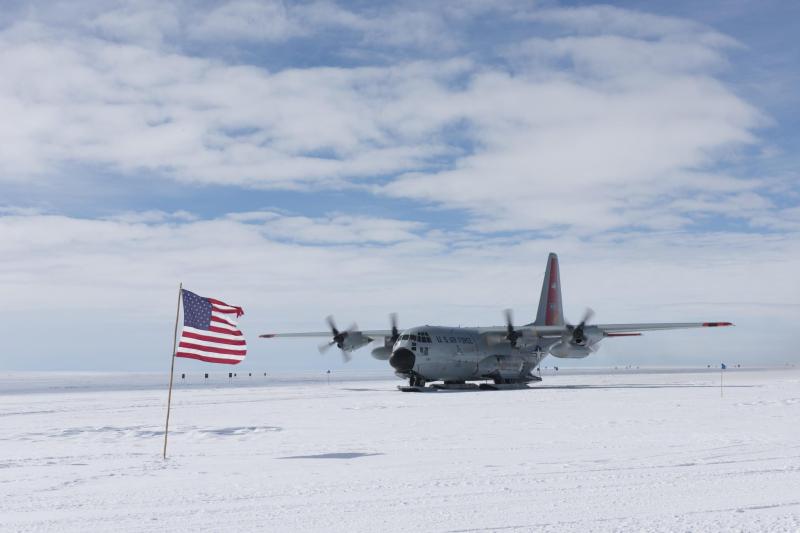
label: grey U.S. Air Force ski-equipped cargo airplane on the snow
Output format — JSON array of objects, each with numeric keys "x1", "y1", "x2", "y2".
[{"x1": 261, "y1": 253, "x2": 732, "y2": 391}]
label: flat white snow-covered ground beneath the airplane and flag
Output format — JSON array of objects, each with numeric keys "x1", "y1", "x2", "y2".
[{"x1": 0, "y1": 369, "x2": 800, "y2": 532}]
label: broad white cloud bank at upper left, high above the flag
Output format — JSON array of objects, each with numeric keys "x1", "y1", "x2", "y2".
[{"x1": 0, "y1": 21, "x2": 468, "y2": 187}]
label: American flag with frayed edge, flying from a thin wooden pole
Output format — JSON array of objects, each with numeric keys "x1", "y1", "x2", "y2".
[{"x1": 175, "y1": 289, "x2": 247, "y2": 365}]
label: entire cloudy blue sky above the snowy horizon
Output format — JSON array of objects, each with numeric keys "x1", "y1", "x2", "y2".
[{"x1": 0, "y1": 0, "x2": 800, "y2": 373}]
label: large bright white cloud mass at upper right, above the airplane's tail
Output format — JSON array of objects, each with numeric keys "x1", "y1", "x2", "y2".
[{"x1": 385, "y1": 26, "x2": 768, "y2": 232}]
